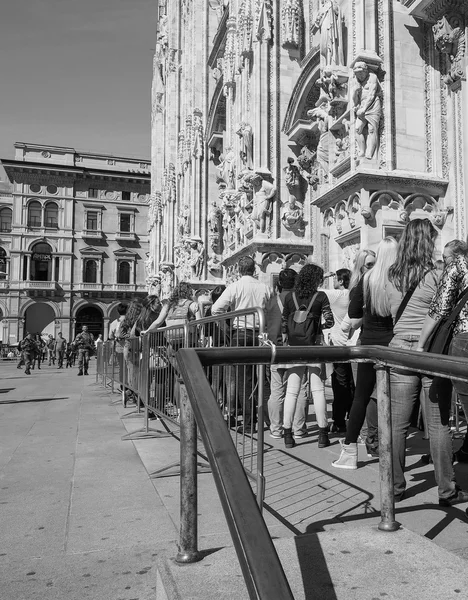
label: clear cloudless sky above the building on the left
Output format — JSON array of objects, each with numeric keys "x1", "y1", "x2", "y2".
[{"x1": 0, "y1": 0, "x2": 157, "y2": 166}]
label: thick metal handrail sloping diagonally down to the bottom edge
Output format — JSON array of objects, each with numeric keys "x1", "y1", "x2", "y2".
[{"x1": 177, "y1": 348, "x2": 294, "y2": 600}]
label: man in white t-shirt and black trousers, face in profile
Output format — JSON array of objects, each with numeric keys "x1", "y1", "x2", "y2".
[{"x1": 323, "y1": 269, "x2": 354, "y2": 433}]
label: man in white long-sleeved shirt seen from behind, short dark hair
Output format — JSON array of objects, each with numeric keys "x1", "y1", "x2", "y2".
[{"x1": 211, "y1": 256, "x2": 271, "y2": 434}]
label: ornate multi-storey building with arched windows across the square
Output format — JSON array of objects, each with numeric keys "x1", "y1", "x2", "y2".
[{"x1": 0, "y1": 143, "x2": 150, "y2": 345}]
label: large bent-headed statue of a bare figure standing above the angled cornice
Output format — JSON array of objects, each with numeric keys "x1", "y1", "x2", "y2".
[{"x1": 352, "y1": 61, "x2": 382, "y2": 159}]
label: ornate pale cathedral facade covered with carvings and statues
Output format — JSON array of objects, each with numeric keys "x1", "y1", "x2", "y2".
[{"x1": 149, "y1": 0, "x2": 468, "y2": 287}]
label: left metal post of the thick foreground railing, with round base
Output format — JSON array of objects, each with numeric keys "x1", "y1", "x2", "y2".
[{"x1": 175, "y1": 380, "x2": 203, "y2": 563}]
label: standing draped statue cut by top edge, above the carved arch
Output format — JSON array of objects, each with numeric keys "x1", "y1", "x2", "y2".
[{"x1": 314, "y1": 0, "x2": 345, "y2": 66}]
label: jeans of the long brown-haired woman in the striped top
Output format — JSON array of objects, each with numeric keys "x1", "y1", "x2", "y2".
[{"x1": 389, "y1": 335, "x2": 456, "y2": 498}]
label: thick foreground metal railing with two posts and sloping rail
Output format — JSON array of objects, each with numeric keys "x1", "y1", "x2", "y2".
[{"x1": 176, "y1": 346, "x2": 468, "y2": 600}]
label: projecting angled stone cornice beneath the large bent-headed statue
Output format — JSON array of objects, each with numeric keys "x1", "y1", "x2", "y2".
[{"x1": 312, "y1": 169, "x2": 448, "y2": 210}]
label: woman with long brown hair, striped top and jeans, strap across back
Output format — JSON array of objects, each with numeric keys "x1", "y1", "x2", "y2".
[{"x1": 387, "y1": 219, "x2": 462, "y2": 504}]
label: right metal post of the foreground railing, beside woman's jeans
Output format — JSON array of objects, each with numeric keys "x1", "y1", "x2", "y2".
[{"x1": 375, "y1": 363, "x2": 400, "y2": 531}]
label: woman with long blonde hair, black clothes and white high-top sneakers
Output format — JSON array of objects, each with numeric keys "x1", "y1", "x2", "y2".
[{"x1": 332, "y1": 237, "x2": 397, "y2": 469}]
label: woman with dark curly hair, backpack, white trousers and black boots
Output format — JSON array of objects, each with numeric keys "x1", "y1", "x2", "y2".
[{"x1": 282, "y1": 264, "x2": 335, "y2": 448}]
